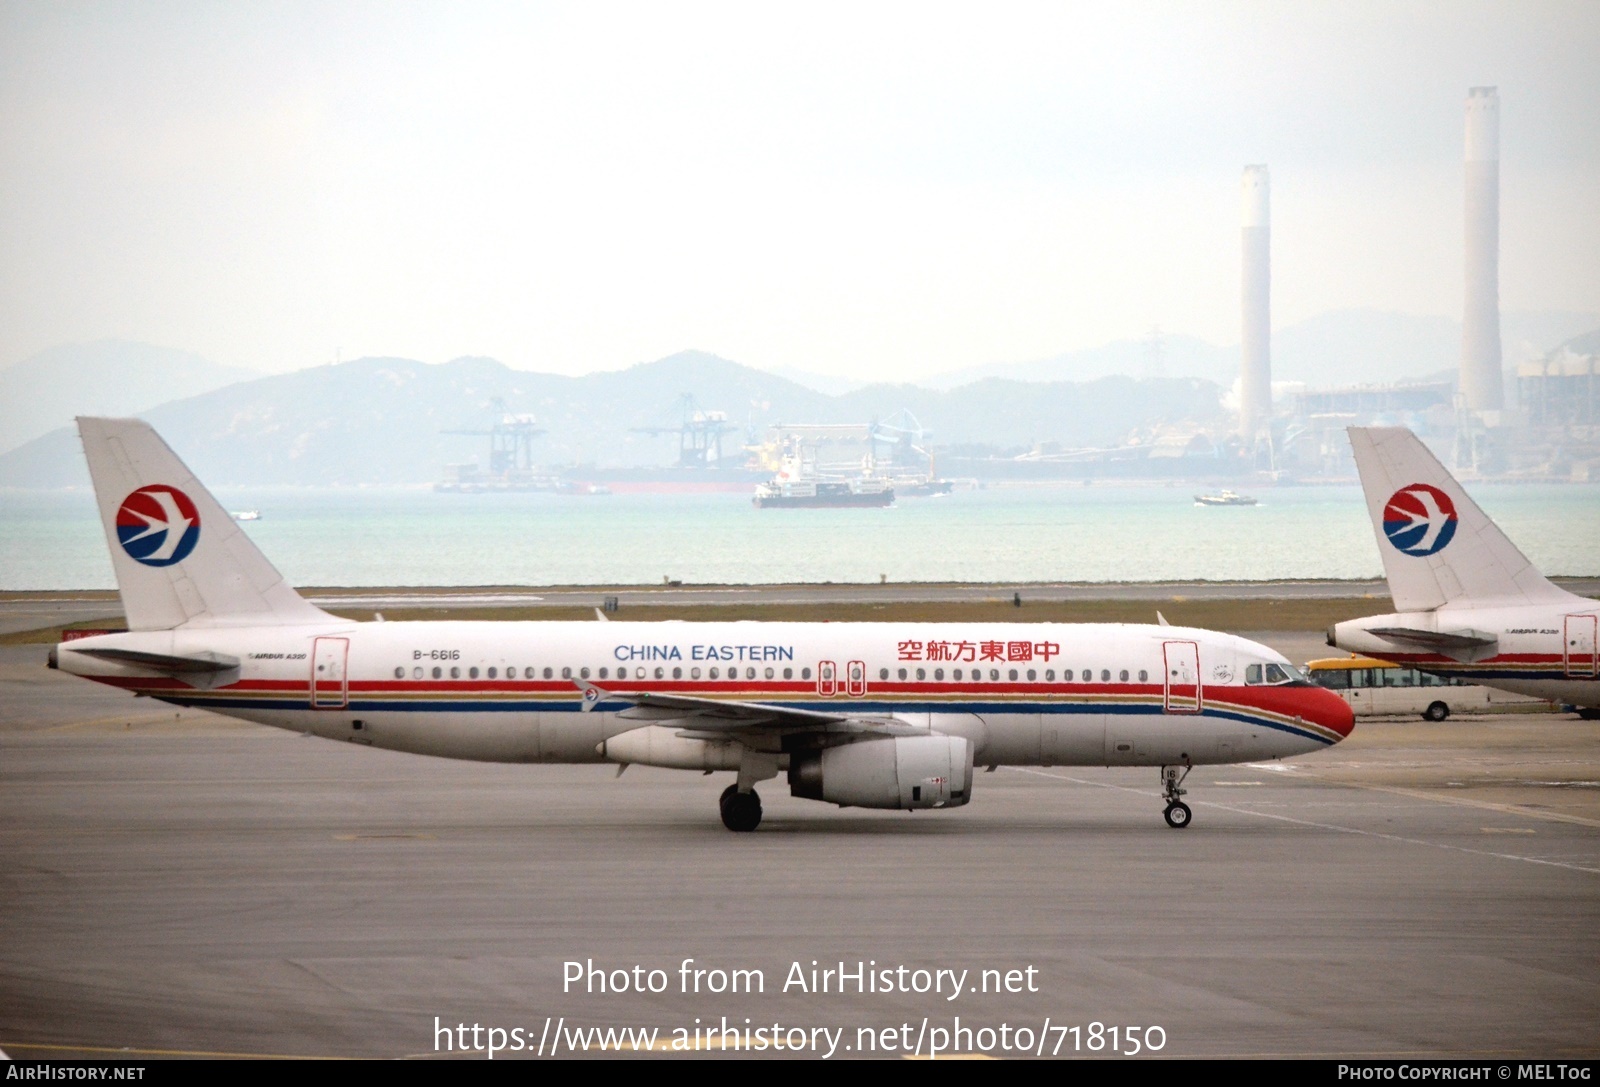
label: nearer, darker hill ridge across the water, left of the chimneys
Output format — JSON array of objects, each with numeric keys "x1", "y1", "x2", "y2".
[{"x1": 0, "y1": 352, "x2": 1221, "y2": 487}]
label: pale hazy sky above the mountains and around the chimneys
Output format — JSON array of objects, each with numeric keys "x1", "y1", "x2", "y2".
[{"x1": 0, "y1": 0, "x2": 1600, "y2": 379}]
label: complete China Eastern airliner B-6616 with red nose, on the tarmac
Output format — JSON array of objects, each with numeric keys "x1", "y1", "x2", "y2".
[{"x1": 51, "y1": 419, "x2": 1352, "y2": 831}]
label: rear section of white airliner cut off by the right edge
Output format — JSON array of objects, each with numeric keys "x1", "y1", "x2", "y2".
[{"x1": 1328, "y1": 427, "x2": 1600, "y2": 717}]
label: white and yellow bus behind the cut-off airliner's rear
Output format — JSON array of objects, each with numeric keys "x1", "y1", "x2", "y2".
[{"x1": 1306, "y1": 656, "x2": 1555, "y2": 720}]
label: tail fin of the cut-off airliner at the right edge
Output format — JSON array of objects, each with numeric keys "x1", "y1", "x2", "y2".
[{"x1": 1350, "y1": 426, "x2": 1571, "y2": 612}]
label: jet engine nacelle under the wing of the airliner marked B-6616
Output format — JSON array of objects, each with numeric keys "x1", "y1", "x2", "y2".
[{"x1": 789, "y1": 736, "x2": 973, "y2": 808}]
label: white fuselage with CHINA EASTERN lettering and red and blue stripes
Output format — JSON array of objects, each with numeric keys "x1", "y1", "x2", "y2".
[{"x1": 56, "y1": 621, "x2": 1352, "y2": 770}]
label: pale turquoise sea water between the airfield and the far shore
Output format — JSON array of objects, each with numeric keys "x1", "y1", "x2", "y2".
[{"x1": 0, "y1": 483, "x2": 1600, "y2": 589}]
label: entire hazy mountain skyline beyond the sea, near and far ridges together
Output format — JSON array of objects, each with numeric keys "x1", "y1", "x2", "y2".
[{"x1": 0, "y1": 311, "x2": 1600, "y2": 487}]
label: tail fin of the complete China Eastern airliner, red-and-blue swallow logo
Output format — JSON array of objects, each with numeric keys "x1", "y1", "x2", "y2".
[{"x1": 78, "y1": 418, "x2": 333, "y2": 631}]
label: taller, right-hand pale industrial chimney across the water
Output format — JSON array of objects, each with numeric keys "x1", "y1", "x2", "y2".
[{"x1": 1461, "y1": 86, "x2": 1506, "y2": 411}]
